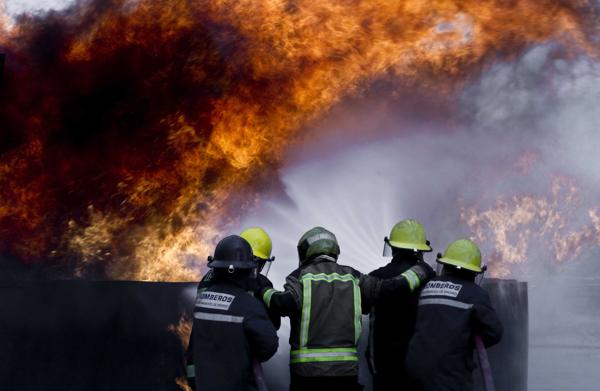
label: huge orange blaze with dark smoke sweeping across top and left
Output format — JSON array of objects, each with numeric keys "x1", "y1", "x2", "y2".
[{"x1": 0, "y1": 0, "x2": 598, "y2": 281}]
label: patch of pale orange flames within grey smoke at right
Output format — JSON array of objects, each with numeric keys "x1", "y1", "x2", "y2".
[{"x1": 461, "y1": 175, "x2": 600, "y2": 277}]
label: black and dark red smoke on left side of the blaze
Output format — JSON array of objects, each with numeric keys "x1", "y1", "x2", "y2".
[{"x1": 0, "y1": 0, "x2": 276, "y2": 276}]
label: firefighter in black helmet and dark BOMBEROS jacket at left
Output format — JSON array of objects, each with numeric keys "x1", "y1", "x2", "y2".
[{"x1": 192, "y1": 235, "x2": 278, "y2": 391}]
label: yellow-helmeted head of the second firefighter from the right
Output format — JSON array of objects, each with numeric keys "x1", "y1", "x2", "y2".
[{"x1": 383, "y1": 219, "x2": 431, "y2": 260}]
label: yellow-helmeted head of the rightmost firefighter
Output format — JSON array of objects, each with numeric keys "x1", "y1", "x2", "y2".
[{"x1": 437, "y1": 239, "x2": 485, "y2": 279}]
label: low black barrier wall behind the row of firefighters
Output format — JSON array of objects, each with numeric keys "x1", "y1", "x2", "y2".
[{"x1": 0, "y1": 280, "x2": 528, "y2": 391}]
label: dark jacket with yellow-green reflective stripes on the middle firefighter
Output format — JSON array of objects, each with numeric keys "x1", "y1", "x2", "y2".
[{"x1": 263, "y1": 255, "x2": 414, "y2": 377}]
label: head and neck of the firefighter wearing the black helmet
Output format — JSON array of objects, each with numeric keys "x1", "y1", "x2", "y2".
[{"x1": 208, "y1": 235, "x2": 257, "y2": 279}]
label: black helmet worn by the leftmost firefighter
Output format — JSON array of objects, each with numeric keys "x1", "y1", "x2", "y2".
[{"x1": 208, "y1": 235, "x2": 257, "y2": 272}]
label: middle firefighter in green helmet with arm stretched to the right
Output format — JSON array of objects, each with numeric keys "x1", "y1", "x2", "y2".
[{"x1": 263, "y1": 227, "x2": 433, "y2": 391}]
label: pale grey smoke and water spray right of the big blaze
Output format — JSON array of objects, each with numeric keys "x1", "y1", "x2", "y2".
[{"x1": 236, "y1": 44, "x2": 600, "y2": 391}]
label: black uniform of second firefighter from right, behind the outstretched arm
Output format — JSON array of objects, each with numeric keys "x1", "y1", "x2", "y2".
[{"x1": 367, "y1": 256, "x2": 420, "y2": 391}]
